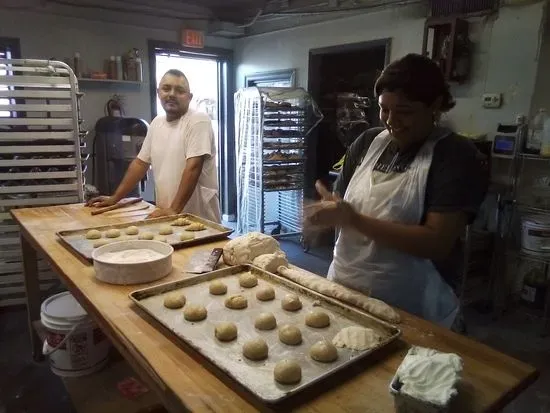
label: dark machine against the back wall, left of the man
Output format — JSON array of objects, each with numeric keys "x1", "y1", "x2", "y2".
[{"x1": 92, "y1": 116, "x2": 149, "y2": 197}]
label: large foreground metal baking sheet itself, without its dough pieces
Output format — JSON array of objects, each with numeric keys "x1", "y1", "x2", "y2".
[{"x1": 129, "y1": 265, "x2": 401, "y2": 403}]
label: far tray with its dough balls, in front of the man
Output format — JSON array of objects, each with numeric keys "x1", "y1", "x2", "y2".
[{"x1": 57, "y1": 214, "x2": 233, "y2": 261}]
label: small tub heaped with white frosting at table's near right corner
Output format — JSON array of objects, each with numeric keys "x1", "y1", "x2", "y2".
[{"x1": 390, "y1": 347, "x2": 462, "y2": 413}]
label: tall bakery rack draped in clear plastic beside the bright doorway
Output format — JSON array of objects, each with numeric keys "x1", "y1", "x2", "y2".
[{"x1": 235, "y1": 87, "x2": 322, "y2": 251}]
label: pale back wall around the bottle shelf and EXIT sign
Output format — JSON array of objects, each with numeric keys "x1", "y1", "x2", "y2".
[{"x1": 0, "y1": 9, "x2": 233, "y2": 130}]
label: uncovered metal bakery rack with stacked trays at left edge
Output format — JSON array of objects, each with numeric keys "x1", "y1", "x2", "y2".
[{"x1": 0, "y1": 59, "x2": 86, "y2": 307}]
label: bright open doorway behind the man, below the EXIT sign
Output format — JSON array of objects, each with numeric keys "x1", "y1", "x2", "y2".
[{"x1": 149, "y1": 41, "x2": 236, "y2": 218}]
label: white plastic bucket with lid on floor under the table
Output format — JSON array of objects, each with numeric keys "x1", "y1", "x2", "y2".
[{"x1": 40, "y1": 292, "x2": 110, "y2": 377}]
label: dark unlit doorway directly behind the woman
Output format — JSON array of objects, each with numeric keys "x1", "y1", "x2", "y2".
[{"x1": 306, "y1": 39, "x2": 391, "y2": 197}]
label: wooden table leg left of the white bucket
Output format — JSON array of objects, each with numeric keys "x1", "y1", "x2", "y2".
[{"x1": 20, "y1": 234, "x2": 44, "y2": 361}]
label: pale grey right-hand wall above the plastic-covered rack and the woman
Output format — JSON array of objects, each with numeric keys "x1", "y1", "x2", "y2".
[{"x1": 236, "y1": 3, "x2": 544, "y2": 137}]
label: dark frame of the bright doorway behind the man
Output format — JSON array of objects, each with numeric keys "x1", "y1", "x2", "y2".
[{"x1": 147, "y1": 39, "x2": 237, "y2": 218}]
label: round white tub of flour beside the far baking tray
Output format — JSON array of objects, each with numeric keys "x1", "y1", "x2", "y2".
[{"x1": 92, "y1": 240, "x2": 174, "y2": 285}]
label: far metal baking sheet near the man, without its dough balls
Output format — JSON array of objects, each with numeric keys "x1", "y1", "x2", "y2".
[{"x1": 56, "y1": 214, "x2": 233, "y2": 261}]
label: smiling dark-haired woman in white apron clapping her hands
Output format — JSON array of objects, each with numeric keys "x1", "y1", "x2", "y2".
[{"x1": 305, "y1": 54, "x2": 488, "y2": 328}]
